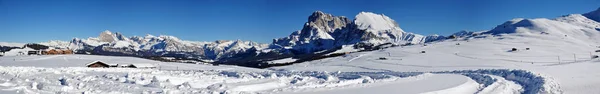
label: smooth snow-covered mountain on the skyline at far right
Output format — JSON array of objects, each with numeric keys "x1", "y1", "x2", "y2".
[{"x1": 483, "y1": 10, "x2": 600, "y2": 43}]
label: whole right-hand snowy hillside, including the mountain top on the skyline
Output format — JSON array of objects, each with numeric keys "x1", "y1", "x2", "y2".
[{"x1": 273, "y1": 8, "x2": 600, "y2": 94}]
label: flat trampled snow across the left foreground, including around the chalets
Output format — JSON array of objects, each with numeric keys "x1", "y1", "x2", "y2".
[{"x1": 0, "y1": 55, "x2": 540, "y2": 94}]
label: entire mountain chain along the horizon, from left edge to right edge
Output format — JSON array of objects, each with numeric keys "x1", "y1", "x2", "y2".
[{"x1": 0, "y1": 9, "x2": 600, "y2": 67}]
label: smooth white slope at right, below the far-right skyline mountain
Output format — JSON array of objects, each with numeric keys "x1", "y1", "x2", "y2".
[{"x1": 271, "y1": 36, "x2": 600, "y2": 94}]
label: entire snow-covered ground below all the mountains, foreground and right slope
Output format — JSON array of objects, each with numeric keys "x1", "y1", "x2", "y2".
[{"x1": 0, "y1": 34, "x2": 600, "y2": 94}]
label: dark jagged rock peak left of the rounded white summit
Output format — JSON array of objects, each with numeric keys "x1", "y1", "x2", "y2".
[{"x1": 273, "y1": 11, "x2": 351, "y2": 53}]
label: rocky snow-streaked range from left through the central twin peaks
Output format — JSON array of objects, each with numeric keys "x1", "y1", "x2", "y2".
[{"x1": 7, "y1": 11, "x2": 446, "y2": 67}]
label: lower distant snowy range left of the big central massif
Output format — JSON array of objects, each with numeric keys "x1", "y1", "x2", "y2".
[{"x1": 61, "y1": 30, "x2": 268, "y2": 60}]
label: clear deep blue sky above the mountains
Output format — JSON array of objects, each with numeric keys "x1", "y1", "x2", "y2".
[{"x1": 0, "y1": 0, "x2": 600, "y2": 43}]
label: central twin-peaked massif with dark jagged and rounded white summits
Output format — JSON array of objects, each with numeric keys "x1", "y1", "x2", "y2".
[{"x1": 273, "y1": 11, "x2": 445, "y2": 53}]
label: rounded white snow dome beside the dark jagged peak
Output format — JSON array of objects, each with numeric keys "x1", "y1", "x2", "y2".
[{"x1": 354, "y1": 12, "x2": 398, "y2": 31}]
